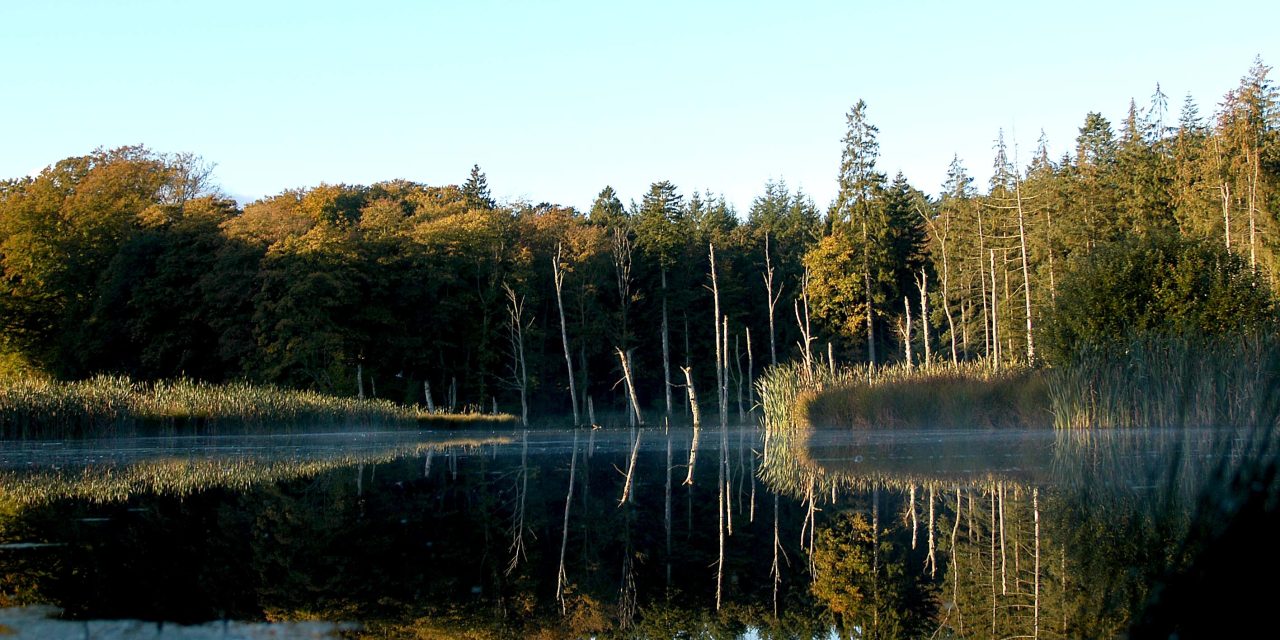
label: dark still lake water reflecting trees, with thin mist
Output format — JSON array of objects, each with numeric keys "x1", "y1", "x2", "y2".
[{"x1": 0, "y1": 426, "x2": 1280, "y2": 637}]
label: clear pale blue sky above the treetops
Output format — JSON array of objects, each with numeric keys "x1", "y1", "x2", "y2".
[{"x1": 0, "y1": 0, "x2": 1280, "y2": 215}]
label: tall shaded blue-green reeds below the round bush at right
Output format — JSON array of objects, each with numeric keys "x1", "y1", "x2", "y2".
[{"x1": 1048, "y1": 334, "x2": 1280, "y2": 429}]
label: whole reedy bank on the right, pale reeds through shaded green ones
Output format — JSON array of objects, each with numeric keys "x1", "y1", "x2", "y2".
[{"x1": 759, "y1": 333, "x2": 1280, "y2": 430}]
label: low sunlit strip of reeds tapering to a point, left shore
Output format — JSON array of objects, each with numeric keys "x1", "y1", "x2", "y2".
[{"x1": 0, "y1": 375, "x2": 516, "y2": 438}]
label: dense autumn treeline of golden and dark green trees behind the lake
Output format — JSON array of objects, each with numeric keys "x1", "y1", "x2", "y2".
[{"x1": 0, "y1": 60, "x2": 1280, "y2": 413}]
